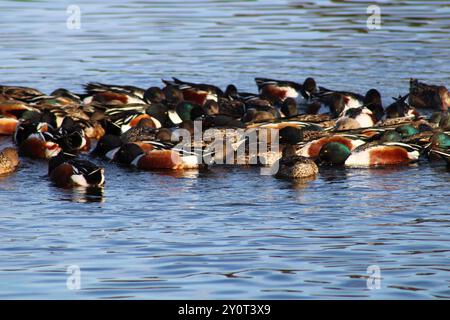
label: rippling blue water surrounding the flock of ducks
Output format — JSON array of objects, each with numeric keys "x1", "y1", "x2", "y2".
[{"x1": 0, "y1": 0, "x2": 450, "y2": 299}]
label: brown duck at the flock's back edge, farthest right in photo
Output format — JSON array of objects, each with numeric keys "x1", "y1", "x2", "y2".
[{"x1": 409, "y1": 79, "x2": 450, "y2": 111}]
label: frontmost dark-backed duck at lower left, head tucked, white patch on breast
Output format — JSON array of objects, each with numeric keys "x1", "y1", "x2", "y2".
[{"x1": 48, "y1": 152, "x2": 105, "y2": 188}]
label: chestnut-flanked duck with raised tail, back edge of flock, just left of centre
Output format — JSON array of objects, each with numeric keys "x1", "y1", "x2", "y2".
[{"x1": 162, "y1": 78, "x2": 224, "y2": 106}]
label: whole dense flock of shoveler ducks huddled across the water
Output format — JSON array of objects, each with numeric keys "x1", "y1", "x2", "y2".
[{"x1": 0, "y1": 78, "x2": 450, "y2": 187}]
